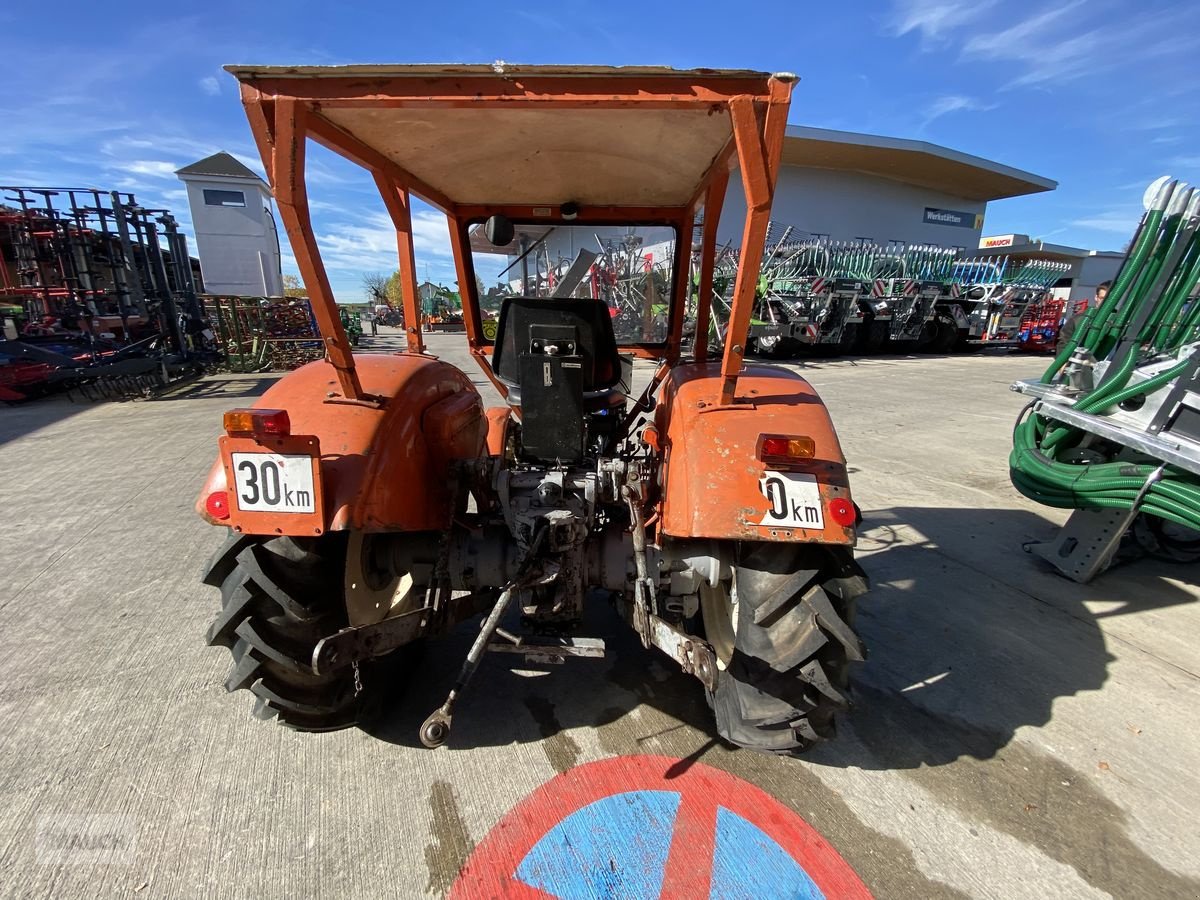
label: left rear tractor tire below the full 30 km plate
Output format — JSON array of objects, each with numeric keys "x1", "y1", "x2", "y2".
[{"x1": 203, "y1": 532, "x2": 386, "y2": 731}]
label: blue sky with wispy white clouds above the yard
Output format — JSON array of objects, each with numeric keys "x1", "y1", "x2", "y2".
[{"x1": 0, "y1": 0, "x2": 1200, "y2": 301}]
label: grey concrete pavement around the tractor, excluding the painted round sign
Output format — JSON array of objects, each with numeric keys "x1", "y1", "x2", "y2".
[{"x1": 0, "y1": 328, "x2": 1200, "y2": 898}]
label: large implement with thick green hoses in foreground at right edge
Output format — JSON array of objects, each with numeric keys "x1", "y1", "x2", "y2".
[{"x1": 1009, "y1": 178, "x2": 1200, "y2": 582}]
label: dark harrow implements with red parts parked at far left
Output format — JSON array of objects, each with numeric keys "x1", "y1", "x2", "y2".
[{"x1": 0, "y1": 186, "x2": 216, "y2": 402}]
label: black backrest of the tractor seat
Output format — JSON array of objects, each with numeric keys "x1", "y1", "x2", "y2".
[{"x1": 492, "y1": 296, "x2": 622, "y2": 391}]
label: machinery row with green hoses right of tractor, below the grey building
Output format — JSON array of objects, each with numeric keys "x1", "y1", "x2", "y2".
[{"x1": 712, "y1": 229, "x2": 1069, "y2": 356}]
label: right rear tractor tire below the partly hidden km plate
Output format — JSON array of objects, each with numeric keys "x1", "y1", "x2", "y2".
[{"x1": 700, "y1": 544, "x2": 866, "y2": 755}]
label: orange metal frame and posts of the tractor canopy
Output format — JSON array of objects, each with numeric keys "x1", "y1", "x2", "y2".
[{"x1": 232, "y1": 67, "x2": 793, "y2": 403}]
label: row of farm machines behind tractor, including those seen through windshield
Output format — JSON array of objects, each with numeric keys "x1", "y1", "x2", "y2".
[{"x1": 472, "y1": 223, "x2": 1070, "y2": 356}]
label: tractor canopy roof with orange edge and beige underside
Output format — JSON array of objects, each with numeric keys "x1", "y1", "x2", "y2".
[{"x1": 227, "y1": 62, "x2": 792, "y2": 214}]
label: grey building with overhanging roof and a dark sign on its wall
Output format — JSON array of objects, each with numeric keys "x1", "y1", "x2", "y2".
[{"x1": 718, "y1": 125, "x2": 1058, "y2": 252}]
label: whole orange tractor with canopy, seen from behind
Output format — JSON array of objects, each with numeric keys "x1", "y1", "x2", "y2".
[{"x1": 197, "y1": 64, "x2": 866, "y2": 752}]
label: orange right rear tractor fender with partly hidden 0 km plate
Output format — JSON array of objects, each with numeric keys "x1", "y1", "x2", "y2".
[{"x1": 655, "y1": 362, "x2": 854, "y2": 545}]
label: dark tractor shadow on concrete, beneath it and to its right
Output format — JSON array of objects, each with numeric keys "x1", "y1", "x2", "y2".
[{"x1": 371, "y1": 508, "x2": 1193, "y2": 769}]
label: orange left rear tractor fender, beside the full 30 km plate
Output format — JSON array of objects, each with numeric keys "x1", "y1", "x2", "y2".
[{"x1": 196, "y1": 354, "x2": 487, "y2": 535}]
